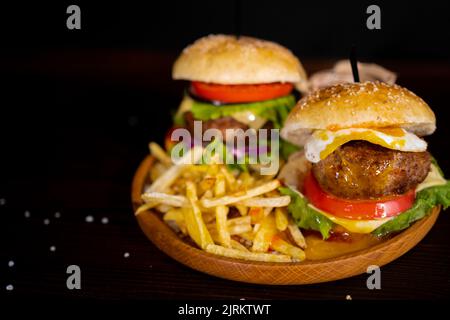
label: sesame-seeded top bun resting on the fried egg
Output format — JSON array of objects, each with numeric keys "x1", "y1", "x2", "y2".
[{"x1": 281, "y1": 82, "x2": 436, "y2": 145}]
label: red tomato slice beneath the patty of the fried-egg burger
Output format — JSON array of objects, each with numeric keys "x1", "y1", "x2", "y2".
[{"x1": 303, "y1": 172, "x2": 416, "y2": 220}]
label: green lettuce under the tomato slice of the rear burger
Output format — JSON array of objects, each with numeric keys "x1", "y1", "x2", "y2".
[{"x1": 191, "y1": 95, "x2": 295, "y2": 129}]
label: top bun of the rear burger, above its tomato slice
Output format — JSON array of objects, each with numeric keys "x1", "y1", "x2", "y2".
[{"x1": 172, "y1": 35, "x2": 306, "y2": 88}]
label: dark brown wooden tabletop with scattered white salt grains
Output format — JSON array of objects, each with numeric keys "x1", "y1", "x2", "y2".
[{"x1": 0, "y1": 51, "x2": 450, "y2": 300}]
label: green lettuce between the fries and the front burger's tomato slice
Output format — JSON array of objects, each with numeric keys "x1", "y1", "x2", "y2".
[{"x1": 278, "y1": 187, "x2": 334, "y2": 239}]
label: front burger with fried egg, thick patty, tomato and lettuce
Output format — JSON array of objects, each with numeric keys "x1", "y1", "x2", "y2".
[{"x1": 280, "y1": 82, "x2": 450, "y2": 243}]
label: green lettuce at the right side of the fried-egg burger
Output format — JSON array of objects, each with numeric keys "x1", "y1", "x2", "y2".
[{"x1": 372, "y1": 181, "x2": 450, "y2": 237}]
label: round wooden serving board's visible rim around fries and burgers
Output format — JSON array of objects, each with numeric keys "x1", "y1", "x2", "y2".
[{"x1": 131, "y1": 156, "x2": 440, "y2": 285}]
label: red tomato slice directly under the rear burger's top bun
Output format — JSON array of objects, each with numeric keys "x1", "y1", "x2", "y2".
[{"x1": 191, "y1": 81, "x2": 294, "y2": 103}]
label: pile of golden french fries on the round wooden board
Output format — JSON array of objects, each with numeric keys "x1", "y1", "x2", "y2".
[{"x1": 136, "y1": 143, "x2": 306, "y2": 262}]
